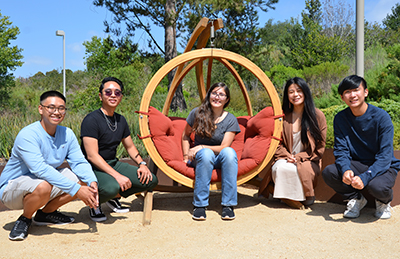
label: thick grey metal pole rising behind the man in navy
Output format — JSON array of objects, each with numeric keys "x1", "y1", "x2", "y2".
[{"x1": 356, "y1": 0, "x2": 364, "y2": 77}]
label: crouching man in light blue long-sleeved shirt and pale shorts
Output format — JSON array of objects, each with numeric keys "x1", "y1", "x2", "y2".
[{"x1": 0, "y1": 91, "x2": 98, "y2": 240}]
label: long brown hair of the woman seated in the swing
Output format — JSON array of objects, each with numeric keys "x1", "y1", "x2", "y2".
[{"x1": 192, "y1": 82, "x2": 231, "y2": 138}]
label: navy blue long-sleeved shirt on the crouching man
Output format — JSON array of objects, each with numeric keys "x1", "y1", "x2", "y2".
[{"x1": 333, "y1": 104, "x2": 400, "y2": 185}]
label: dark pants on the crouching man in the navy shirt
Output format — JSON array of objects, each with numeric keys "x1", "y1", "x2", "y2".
[{"x1": 322, "y1": 161, "x2": 397, "y2": 204}]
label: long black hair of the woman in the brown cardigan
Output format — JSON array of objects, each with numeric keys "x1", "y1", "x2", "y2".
[{"x1": 282, "y1": 77, "x2": 323, "y2": 146}]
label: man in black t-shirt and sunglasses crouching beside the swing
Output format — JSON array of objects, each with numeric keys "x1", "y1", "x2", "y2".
[{"x1": 81, "y1": 77, "x2": 158, "y2": 222}]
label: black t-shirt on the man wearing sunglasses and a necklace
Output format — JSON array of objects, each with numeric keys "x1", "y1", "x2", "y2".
[{"x1": 81, "y1": 109, "x2": 131, "y2": 160}]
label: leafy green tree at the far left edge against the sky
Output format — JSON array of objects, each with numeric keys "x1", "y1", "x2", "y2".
[{"x1": 0, "y1": 13, "x2": 23, "y2": 106}]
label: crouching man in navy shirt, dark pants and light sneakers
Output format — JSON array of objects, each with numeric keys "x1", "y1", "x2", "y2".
[{"x1": 322, "y1": 75, "x2": 400, "y2": 219}]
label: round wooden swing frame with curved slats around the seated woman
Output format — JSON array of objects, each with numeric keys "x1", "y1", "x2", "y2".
[{"x1": 138, "y1": 18, "x2": 282, "y2": 189}]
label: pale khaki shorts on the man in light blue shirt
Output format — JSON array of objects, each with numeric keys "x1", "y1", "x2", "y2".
[{"x1": 2, "y1": 168, "x2": 79, "y2": 210}]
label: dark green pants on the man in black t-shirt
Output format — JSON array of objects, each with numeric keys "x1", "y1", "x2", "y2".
[{"x1": 93, "y1": 159, "x2": 158, "y2": 203}]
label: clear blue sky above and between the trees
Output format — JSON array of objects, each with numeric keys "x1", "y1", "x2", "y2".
[{"x1": 0, "y1": 0, "x2": 400, "y2": 77}]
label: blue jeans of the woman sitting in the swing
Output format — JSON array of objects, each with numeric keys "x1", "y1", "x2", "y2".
[{"x1": 191, "y1": 147, "x2": 238, "y2": 207}]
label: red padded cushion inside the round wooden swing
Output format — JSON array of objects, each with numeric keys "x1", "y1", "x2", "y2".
[{"x1": 149, "y1": 107, "x2": 274, "y2": 182}]
